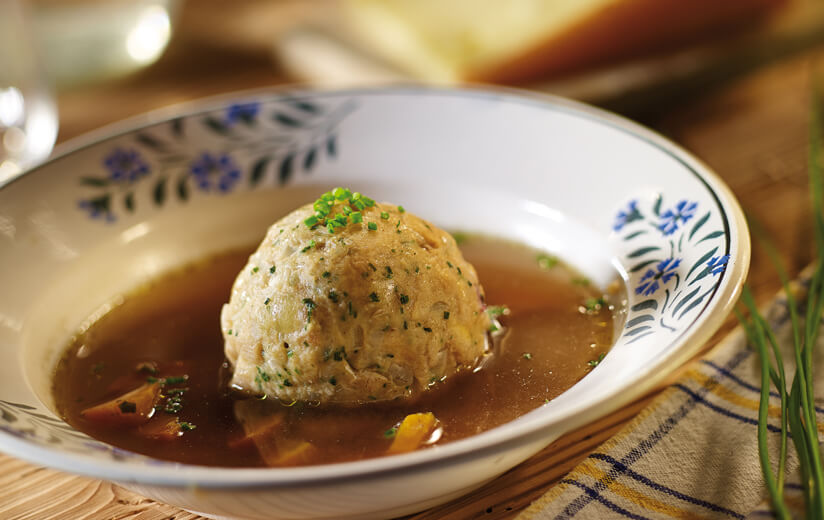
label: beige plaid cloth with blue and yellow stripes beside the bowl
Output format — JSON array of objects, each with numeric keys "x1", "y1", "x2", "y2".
[{"x1": 518, "y1": 272, "x2": 824, "y2": 520}]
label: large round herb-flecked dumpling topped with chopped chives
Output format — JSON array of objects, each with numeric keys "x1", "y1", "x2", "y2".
[{"x1": 221, "y1": 188, "x2": 489, "y2": 404}]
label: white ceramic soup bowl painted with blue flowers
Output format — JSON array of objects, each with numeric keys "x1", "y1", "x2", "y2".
[{"x1": 0, "y1": 87, "x2": 750, "y2": 519}]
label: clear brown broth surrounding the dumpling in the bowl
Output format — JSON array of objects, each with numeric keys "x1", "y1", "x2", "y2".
[{"x1": 53, "y1": 237, "x2": 614, "y2": 466}]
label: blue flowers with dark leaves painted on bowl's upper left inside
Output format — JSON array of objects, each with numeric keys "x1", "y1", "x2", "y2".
[{"x1": 77, "y1": 99, "x2": 355, "y2": 222}]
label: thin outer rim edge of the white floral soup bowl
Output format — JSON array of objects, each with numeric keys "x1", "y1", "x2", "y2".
[{"x1": 0, "y1": 83, "x2": 751, "y2": 488}]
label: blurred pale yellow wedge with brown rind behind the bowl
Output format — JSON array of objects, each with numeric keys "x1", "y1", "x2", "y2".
[{"x1": 343, "y1": 0, "x2": 789, "y2": 83}]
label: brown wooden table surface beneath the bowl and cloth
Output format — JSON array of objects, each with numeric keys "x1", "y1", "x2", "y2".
[{"x1": 0, "y1": 3, "x2": 824, "y2": 520}]
